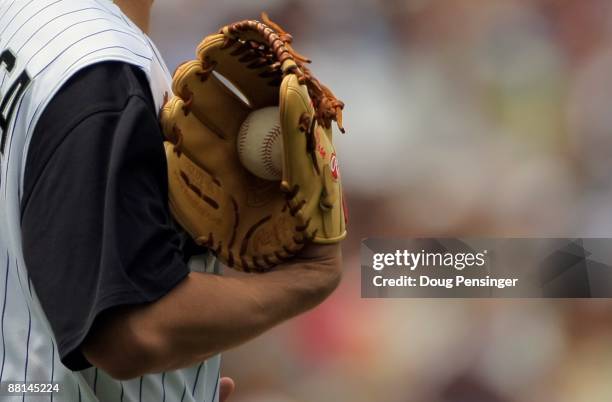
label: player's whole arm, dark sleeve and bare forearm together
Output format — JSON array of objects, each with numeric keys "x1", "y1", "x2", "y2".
[{"x1": 22, "y1": 63, "x2": 340, "y2": 378}]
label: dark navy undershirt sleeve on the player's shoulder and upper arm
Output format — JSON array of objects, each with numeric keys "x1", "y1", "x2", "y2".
[{"x1": 22, "y1": 62, "x2": 189, "y2": 370}]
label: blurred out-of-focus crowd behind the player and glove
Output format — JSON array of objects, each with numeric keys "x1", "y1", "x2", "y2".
[{"x1": 152, "y1": 0, "x2": 612, "y2": 402}]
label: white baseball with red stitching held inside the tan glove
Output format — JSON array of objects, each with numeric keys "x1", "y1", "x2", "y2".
[{"x1": 237, "y1": 106, "x2": 283, "y2": 180}]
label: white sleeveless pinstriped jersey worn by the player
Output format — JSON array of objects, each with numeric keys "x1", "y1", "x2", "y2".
[{"x1": 0, "y1": 0, "x2": 220, "y2": 402}]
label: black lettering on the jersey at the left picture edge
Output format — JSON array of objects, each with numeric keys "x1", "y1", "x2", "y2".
[{"x1": 0, "y1": 49, "x2": 30, "y2": 155}]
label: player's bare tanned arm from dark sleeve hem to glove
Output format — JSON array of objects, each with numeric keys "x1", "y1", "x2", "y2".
[{"x1": 82, "y1": 245, "x2": 341, "y2": 379}]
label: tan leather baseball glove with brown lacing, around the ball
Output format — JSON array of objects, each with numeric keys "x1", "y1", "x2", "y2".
[{"x1": 160, "y1": 14, "x2": 346, "y2": 271}]
